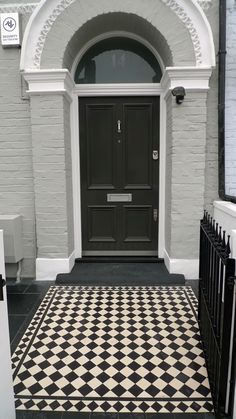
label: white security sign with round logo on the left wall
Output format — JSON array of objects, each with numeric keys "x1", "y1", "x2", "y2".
[{"x1": 1, "y1": 13, "x2": 20, "y2": 46}]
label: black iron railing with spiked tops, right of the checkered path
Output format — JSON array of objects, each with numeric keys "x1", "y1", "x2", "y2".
[{"x1": 198, "y1": 211, "x2": 236, "y2": 414}]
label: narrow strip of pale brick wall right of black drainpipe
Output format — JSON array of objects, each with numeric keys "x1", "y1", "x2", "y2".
[{"x1": 225, "y1": 0, "x2": 236, "y2": 196}]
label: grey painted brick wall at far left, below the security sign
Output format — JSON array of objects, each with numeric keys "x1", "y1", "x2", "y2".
[{"x1": 0, "y1": 11, "x2": 35, "y2": 277}]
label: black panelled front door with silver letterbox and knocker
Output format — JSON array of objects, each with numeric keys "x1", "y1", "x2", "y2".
[{"x1": 79, "y1": 97, "x2": 159, "y2": 255}]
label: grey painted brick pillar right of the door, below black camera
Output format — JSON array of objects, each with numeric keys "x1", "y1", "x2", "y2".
[{"x1": 166, "y1": 92, "x2": 207, "y2": 259}]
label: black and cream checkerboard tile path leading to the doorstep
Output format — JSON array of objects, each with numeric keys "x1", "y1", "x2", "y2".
[{"x1": 12, "y1": 286, "x2": 213, "y2": 413}]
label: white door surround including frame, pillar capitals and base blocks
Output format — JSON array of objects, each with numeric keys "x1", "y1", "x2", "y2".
[{"x1": 24, "y1": 67, "x2": 212, "y2": 279}]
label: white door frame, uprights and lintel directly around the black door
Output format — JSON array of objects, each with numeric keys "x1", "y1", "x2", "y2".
[{"x1": 71, "y1": 83, "x2": 166, "y2": 258}]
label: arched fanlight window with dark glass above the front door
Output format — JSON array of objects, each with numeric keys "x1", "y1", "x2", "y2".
[{"x1": 75, "y1": 37, "x2": 162, "y2": 84}]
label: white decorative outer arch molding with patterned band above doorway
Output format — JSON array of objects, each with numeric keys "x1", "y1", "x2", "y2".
[{"x1": 21, "y1": 0, "x2": 215, "y2": 70}]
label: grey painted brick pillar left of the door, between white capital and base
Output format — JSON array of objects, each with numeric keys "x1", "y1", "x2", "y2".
[{"x1": 30, "y1": 94, "x2": 73, "y2": 258}]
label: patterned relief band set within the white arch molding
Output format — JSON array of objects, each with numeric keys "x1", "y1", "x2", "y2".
[{"x1": 33, "y1": 0, "x2": 203, "y2": 68}]
